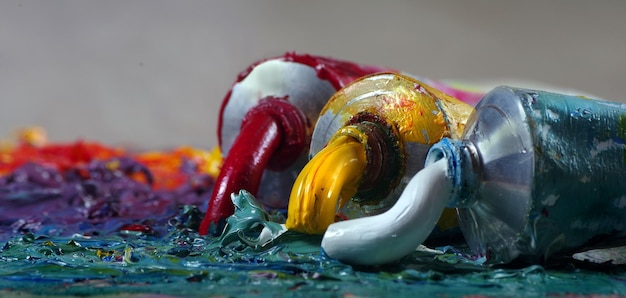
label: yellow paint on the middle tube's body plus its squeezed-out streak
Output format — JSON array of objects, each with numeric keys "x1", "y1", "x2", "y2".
[{"x1": 286, "y1": 73, "x2": 473, "y2": 234}]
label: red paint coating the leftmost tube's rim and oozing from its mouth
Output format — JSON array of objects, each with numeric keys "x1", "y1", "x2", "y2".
[{"x1": 204, "y1": 52, "x2": 389, "y2": 235}]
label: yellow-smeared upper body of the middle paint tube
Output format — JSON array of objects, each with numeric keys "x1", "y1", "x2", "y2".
[{"x1": 320, "y1": 73, "x2": 472, "y2": 144}]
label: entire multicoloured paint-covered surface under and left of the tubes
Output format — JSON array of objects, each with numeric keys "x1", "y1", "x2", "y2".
[{"x1": 0, "y1": 132, "x2": 626, "y2": 297}]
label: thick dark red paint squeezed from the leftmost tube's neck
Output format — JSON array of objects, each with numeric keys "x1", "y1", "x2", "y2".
[{"x1": 200, "y1": 98, "x2": 310, "y2": 235}]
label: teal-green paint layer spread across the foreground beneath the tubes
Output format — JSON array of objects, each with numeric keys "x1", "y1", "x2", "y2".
[{"x1": 0, "y1": 193, "x2": 626, "y2": 297}]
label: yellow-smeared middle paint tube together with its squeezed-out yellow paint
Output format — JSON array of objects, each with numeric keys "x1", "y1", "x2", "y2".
[{"x1": 286, "y1": 73, "x2": 472, "y2": 234}]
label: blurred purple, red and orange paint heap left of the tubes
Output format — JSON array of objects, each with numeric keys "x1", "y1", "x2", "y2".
[{"x1": 0, "y1": 131, "x2": 220, "y2": 240}]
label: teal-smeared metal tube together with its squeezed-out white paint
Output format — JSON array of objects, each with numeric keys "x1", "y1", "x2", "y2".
[{"x1": 322, "y1": 86, "x2": 626, "y2": 265}]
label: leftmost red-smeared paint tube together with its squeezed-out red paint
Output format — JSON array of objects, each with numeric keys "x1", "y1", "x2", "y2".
[{"x1": 200, "y1": 53, "x2": 385, "y2": 235}]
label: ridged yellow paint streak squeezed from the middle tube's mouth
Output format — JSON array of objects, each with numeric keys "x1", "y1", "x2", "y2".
[{"x1": 285, "y1": 135, "x2": 367, "y2": 234}]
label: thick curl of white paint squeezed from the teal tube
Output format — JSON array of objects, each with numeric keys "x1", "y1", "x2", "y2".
[{"x1": 322, "y1": 159, "x2": 452, "y2": 265}]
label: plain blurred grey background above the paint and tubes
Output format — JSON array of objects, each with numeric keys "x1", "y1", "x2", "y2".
[{"x1": 0, "y1": 0, "x2": 626, "y2": 149}]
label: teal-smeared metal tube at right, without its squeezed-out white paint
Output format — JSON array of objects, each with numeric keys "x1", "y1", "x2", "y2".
[{"x1": 427, "y1": 87, "x2": 626, "y2": 263}]
